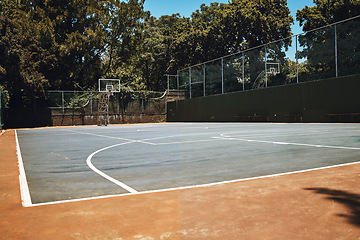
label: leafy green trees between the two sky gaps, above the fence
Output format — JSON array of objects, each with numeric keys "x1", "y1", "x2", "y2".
[{"x1": 131, "y1": 0, "x2": 293, "y2": 90}]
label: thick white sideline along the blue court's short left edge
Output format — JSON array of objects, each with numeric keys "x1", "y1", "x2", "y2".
[{"x1": 15, "y1": 130, "x2": 32, "y2": 207}]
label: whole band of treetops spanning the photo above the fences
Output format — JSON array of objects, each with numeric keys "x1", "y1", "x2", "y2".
[{"x1": 6, "y1": 0, "x2": 352, "y2": 106}]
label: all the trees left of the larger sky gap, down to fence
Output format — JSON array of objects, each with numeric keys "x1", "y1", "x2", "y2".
[{"x1": 0, "y1": 0, "x2": 149, "y2": 105}]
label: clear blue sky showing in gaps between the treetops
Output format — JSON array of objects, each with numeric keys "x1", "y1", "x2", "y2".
[{"x1": 145, "y1": 0, "x2": 314, "y2": 34}]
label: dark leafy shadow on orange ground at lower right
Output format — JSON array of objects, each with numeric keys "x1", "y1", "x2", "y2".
[{"x1": 305, "y1": 188, "x2": 360, "y2": 227}]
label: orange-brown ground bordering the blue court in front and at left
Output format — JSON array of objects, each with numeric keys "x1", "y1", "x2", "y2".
[{"x1": 0, "y1": 130, "x2": 360, "y2": 240}]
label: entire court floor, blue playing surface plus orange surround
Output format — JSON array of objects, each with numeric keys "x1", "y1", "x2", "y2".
[{"x1": 0, "y1": 123, "x2": 360, "y2": 240}]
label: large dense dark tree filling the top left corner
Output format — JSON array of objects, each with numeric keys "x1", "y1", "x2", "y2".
[{"x1": 0, "y1": 0, "x2": 106, "y2": 106}]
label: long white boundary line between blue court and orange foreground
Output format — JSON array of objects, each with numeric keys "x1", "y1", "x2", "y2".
[{"x1": 29, "y1": 159, "x2": 360, "y2": 207}]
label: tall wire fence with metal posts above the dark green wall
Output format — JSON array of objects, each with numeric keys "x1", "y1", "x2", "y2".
[{"x1": 168, "y1": 16, "x2": 360, "y2": 98}]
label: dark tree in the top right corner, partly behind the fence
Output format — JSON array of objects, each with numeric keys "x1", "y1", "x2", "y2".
[{"x1": 296, "y1": 0, "x2": 360, "y2": 78}]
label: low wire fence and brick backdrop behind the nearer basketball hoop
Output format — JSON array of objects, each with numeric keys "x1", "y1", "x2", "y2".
[{"x1": 47, "y1": 91, "x2": 166, "y2": 125}]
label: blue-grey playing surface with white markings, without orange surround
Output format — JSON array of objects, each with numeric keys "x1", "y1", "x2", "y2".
[{"x1": 17, "y1": 123, "x2": 360, "y2": 204}]
